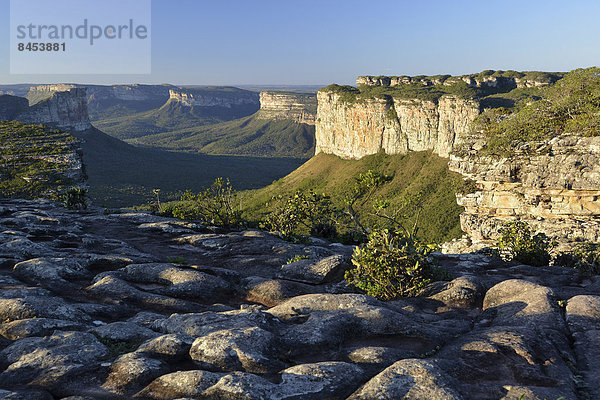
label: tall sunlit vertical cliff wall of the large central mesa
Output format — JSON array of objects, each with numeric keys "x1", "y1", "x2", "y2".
[{"x1": 316, "y1": 91, "x2": 480, "y2": 158}]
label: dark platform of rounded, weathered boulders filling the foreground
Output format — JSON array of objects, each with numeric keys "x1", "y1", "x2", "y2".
[{"x1": 0, "y1": 201, "x2": 600, "y2": 400}]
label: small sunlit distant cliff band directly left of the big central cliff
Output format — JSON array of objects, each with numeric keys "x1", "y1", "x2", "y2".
[{"x1": 258, "y1": 91, "x2": 317, "y2": 125}]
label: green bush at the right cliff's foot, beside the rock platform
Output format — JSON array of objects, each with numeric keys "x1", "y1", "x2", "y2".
[{"x1": 498, "y1": 219, "x2": 555, "y2": 266}]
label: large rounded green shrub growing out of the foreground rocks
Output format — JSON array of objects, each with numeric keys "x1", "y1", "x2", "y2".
[{"x1": 345, "y1": 229, "x2": 441, "y2": 300}]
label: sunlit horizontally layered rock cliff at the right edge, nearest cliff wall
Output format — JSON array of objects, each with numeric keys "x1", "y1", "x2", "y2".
[{"x1": 449, "y1": 136, "x2": 600, "y2": 248}]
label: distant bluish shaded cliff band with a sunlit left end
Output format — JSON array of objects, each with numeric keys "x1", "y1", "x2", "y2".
[{"x1": 169, "y1": 88, "x2": 259, "y2": 108}]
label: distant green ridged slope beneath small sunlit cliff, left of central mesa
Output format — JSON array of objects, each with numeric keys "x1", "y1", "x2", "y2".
[{"x1": 129, "y1": 115, "x2": 315, "y2": 158}]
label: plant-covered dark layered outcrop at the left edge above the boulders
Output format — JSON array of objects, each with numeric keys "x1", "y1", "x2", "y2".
[{"x1": 0, "y1": 121, "x2": 78, "y2": 198}]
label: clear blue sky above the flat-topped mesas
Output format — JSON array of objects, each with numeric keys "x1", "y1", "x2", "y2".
[{"x1": 0, "y1": 0, "x2": 600, "y2": 85}]
